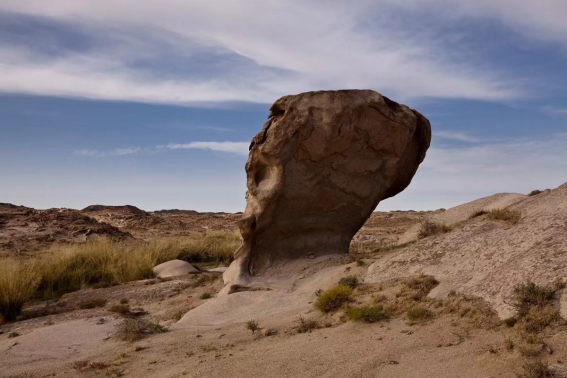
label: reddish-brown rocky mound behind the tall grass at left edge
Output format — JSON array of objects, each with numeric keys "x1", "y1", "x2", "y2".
[{"x1": 0, "y1": 204, "x2": 131, "y2": 255}]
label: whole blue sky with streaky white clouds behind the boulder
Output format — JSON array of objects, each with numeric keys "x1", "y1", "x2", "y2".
[{"x1": 0, "y1": 0, "x2": 567, "y2": 212}]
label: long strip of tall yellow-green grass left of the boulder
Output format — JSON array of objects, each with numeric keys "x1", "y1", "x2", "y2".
[{"x1": 0, "y1": 232, "x2": 240, "y2": 314}]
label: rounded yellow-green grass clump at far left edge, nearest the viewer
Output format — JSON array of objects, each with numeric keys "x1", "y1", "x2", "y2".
[{"x1": 0, "y1": 260, "x2": 40, "y2": 322}]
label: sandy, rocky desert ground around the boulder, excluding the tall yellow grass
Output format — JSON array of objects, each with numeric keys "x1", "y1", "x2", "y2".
[{"x1": 0, "y1": 184, "x2": 567, "y2": 377}]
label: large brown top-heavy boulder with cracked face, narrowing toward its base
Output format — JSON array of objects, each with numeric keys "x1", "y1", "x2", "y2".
[{"x1": 224, "y1": 90, "x2": 431, "y2": 286}]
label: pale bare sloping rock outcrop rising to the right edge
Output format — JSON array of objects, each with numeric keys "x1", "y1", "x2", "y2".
[{"x1": 366, "y1": 185, "x2": 567, "y2": 317}]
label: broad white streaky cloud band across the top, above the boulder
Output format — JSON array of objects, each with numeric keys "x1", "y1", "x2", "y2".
[{"x1": 0, "y1": 0, "x2": 528, "y2": 104}]
